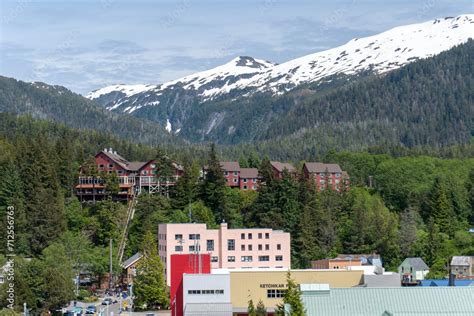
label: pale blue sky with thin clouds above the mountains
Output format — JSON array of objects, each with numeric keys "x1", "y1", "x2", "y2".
[{"x1": 0, "y1": 0, "x2": 474, "y2": 93}]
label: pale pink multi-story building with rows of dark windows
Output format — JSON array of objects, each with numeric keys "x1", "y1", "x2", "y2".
[{"x1": 158, "y1": 223, "x2": 291, "y2": 284}]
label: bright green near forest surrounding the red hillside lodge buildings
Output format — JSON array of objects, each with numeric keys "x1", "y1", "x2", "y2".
[{"x1": 0, "y1": 114, "x2": 474, "y2": 312}]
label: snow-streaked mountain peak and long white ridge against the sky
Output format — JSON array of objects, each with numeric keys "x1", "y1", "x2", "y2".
[{"x1": 86, "y1": 15, "x2": 474, "y2": 133}]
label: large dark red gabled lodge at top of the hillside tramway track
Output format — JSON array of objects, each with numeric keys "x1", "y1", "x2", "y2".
[{"x1": 75, "y1": 148, "x2": 184, "y2": 201}]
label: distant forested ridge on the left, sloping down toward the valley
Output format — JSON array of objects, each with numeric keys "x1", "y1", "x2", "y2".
[{"x1": 0, "y1": 76, "x2": 179, "y2": 145}]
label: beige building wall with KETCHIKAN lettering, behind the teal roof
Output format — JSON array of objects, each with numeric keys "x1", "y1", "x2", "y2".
[{"x1": 230, "y1": 270, "x2": 364, "y2": 312}]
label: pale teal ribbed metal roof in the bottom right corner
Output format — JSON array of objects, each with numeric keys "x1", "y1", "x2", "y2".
[{"x1": 302, "y1": 287, "x2": 474, "y2": 316}]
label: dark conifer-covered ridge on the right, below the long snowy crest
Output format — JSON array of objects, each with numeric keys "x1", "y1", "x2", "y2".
[{"x1": 260, "y1": 40, "x2": 474, "y2": 149}]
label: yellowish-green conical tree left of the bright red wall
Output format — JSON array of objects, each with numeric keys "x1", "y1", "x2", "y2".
[{"x1": 134, "y1": 232, "x2": 169, "y2": 309}]
